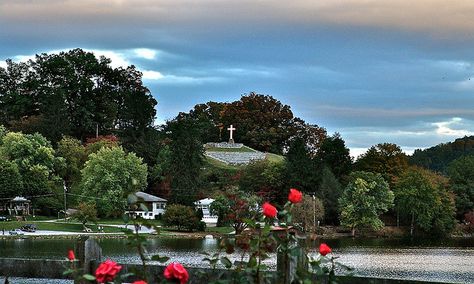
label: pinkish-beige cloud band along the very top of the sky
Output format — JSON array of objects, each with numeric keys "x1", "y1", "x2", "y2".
[{"x1": 0, "y1": 0, "x2": 474, "y2": 39}]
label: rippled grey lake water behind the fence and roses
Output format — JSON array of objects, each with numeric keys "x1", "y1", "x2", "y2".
[{"x1": 0, "y1": 238, "x2": 474, "y2": 283}]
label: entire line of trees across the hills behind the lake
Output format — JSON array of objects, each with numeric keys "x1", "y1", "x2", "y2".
[{"x1": 0, "y1": 49, "x2": 474, "y2": 237}]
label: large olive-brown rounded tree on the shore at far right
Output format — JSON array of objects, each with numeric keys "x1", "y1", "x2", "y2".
[{"x1": 394, "y1": 167, "x2": 455, "y2": 235}]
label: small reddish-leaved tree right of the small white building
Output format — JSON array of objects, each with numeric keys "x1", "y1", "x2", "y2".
[{"x1": 210, "y1": 189, "x2": 261, "y2": 235}]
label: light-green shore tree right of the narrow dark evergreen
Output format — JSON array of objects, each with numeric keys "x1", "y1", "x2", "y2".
[{"x1": 339, "y1": 172, "x2": 394, "y2": 236}]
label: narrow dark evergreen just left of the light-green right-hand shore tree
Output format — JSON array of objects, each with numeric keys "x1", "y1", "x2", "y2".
[{"x1": 319, "y1": 167, "x2": 342, "y2": 224}]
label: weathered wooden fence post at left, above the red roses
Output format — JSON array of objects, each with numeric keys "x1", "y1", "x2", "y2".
[{"x1": 76, "y1": 236, "x2": 102, "y2": 282}]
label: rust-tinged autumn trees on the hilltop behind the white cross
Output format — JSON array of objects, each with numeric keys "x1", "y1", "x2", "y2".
[{"x1": 185, "y1": 92, "x2": 326, "y2": 154}]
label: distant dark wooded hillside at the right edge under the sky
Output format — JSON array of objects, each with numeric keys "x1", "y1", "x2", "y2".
[{"x1": 410, "y1": 136, "x2": 474, "y2": 173}]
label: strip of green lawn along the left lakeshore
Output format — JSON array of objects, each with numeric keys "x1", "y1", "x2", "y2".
[{"x1": 0, "y1": 221, "x2": 122, "y2": 234}]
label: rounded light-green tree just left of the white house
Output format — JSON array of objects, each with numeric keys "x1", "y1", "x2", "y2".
[{"x1": 81, "y1": 147, "x2": 147, "y2": 216}]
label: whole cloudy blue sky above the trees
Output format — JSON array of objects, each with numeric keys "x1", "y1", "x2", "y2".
[{"x1": 0, "y1": 0, "x2": 474, "y2": 157}]
